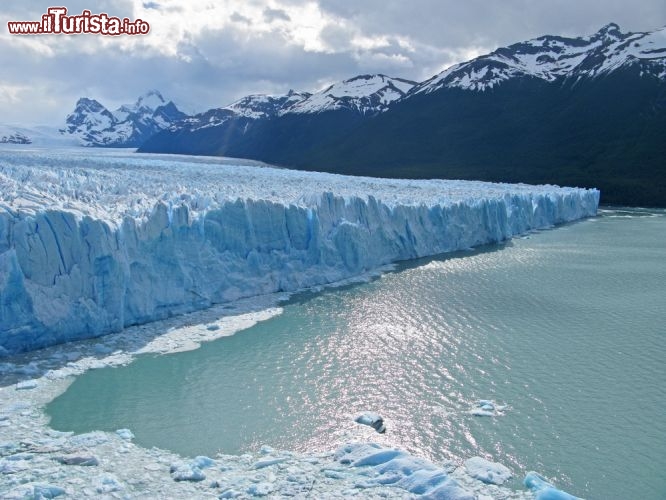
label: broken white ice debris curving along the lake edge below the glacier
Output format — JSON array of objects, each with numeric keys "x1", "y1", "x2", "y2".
[{"x1": 0, "y1": 295, "x2": 574, "y2": 500}]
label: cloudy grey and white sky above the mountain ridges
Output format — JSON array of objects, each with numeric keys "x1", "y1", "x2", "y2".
[{"x1": 0, "y1": 0, "x2": 666, "y2": 125}]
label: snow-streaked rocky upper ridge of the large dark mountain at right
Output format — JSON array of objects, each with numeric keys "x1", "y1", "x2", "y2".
[{"x1": 412, "y1": 23, "x2": 666, "y2": 94}]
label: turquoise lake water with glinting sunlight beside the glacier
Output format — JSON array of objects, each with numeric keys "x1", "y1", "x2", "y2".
[{"x1": 47, "y1": 210, "x2": 666, "y2": 499}]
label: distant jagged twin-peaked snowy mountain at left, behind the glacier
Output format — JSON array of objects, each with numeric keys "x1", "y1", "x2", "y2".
[{"x1": 61, "y1": 90, "x2": 187, "y2": 147}]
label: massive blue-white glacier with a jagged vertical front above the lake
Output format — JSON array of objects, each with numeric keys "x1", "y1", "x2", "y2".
[{"x1": 0, "y1": 147, "x2": 599, "y2": 355}]
